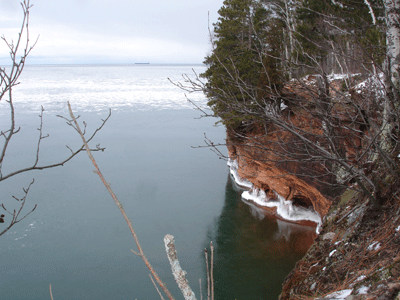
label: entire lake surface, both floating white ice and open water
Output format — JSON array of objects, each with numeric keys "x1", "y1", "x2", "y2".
[{"x1": 0, "y1": 65, "x2": 314, "y2": 300}]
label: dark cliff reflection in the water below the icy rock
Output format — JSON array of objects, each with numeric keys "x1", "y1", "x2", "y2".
[{"x1": 206, "y1": 177, "x2": 315, "y2": 299}]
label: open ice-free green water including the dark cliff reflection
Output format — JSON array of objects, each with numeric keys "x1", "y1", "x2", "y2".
[{"x1": 0, "y1": 110, "x2": 313, "y2": 300}]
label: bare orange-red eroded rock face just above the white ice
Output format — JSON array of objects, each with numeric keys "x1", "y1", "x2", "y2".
[{"x1": 227, "y1": 136, "x2": 331, "y2": 218}]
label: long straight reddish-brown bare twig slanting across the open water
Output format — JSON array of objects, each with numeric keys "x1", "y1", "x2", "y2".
[{"x1": 67, "y1": 102, "x2": 174, "y2": 300}]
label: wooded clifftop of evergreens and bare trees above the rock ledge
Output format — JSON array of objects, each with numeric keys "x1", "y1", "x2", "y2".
[{"x1": 182, "y1": 0, "x2": 400, "y2": 211}]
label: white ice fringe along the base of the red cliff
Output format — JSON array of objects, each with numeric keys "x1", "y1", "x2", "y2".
[{"x1": 228, "y1": 160, "x2": 322, "y2": 233}]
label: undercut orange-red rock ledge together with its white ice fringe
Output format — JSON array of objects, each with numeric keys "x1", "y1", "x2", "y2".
[{"x1": 227, "y1": 136, "x2": 331, "y2": 231}]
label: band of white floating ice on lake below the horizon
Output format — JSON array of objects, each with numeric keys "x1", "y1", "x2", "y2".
[{"x1": 0, "y1": 65, "x2": 207, "y2": 114}]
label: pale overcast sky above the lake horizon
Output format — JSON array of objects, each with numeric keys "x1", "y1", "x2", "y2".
[{"x1": 0, "y1": 0, "x2": 223, "y2": 64}]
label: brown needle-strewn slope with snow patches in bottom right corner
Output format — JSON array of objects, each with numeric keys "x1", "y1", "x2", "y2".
[{"x1": 280, "y1": 189, "x2": 400, "y2": 300}]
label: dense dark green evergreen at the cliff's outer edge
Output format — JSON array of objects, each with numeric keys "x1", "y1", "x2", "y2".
[{"x1": 202, "y1": 0, "x2": 283, "y2": 131}]
